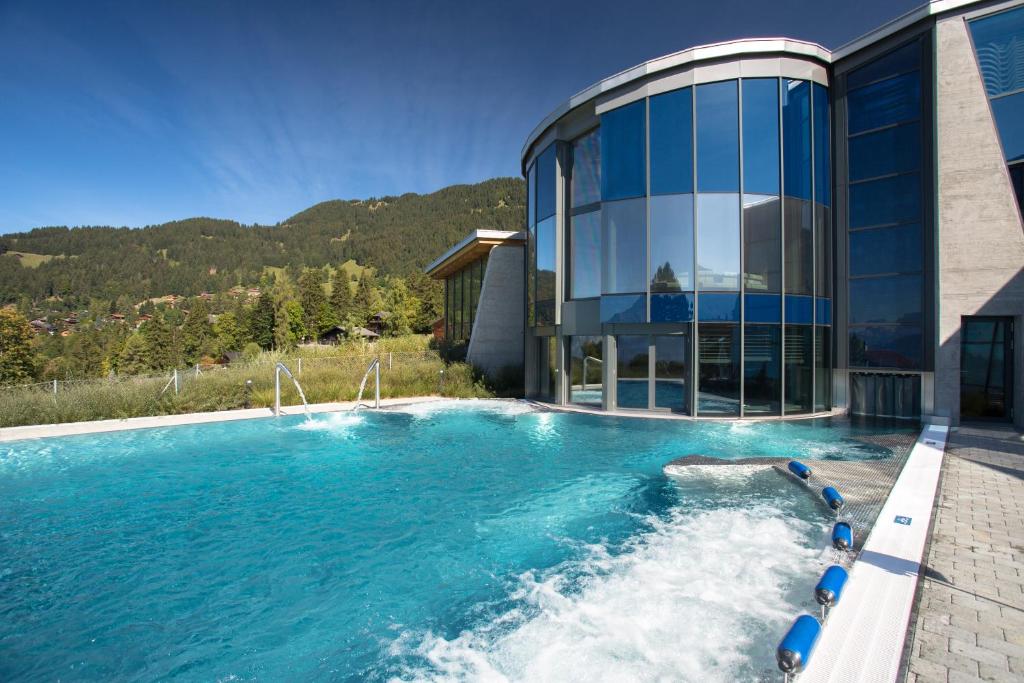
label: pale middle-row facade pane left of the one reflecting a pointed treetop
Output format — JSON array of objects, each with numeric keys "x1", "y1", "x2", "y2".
[{"x1": 601, "y1": 199, "x2": 647, "y2": 294}]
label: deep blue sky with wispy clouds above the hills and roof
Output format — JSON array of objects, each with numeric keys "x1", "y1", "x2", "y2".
[{"x1": 0, "y1": 0, "x2": 919, "y2": 233}]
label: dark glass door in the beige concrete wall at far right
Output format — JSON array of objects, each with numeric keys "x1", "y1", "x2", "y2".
[{"x1": 961, "y1": 316, "x2": 1014, "y2": 420}]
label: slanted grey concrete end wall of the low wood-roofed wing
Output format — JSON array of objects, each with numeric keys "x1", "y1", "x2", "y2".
[{"x1": 466, "y1": 246, "x2": 526, "y2": 375}]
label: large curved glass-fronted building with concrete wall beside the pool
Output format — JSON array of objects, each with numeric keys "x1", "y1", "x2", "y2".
[{"x1": 521, "y1": 2, "x2": 1024, "y2": 423}]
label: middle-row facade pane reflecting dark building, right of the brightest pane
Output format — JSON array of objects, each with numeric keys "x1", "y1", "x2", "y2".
[{"x1": 743, "y1": 195, "x2": 782, "y2": 292}]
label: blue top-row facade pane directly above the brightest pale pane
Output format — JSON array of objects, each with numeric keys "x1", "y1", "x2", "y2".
[{"x1": 696, "y1": 81, "x2": 739, "y2": 193}]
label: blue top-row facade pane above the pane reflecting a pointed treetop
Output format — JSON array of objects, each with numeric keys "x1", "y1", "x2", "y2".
[{"x1": 650, "y1": 88, "x2": 693, "y2": 195}]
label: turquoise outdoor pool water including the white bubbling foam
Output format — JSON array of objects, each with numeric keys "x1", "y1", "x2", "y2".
[{"x1": 0, "y1": 401, "x2": 913, "y2": 681}]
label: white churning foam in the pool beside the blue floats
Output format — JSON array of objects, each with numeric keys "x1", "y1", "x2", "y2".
[{"x1": 391, "y1": 505, "x2": 823, "y2": 681}]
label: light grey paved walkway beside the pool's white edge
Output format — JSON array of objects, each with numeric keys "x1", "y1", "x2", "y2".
[{"x1": 907, "y1": 426, "x2": 1024, "y2": 683}]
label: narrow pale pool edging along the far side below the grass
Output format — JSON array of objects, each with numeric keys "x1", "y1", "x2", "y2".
[{"x1": 0, "y1": 396, "x2": 451, "y2": 442}]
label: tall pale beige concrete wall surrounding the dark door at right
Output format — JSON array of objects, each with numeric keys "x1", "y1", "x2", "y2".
[{"x1": 934, "y1": 16, "x2": 1024, "y2": 426}]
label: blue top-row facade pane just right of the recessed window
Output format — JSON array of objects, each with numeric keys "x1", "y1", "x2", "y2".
[{"x1": 601, "y1": 99, "x2": 647, "y2": 202}]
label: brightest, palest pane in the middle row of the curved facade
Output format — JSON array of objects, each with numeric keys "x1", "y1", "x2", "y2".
[{"x1": 697, "y1": 194, "x2": 739, "y2": 291}]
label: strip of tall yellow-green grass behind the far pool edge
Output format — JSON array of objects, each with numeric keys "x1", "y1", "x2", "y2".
[{"x1": 0, "y1": 337, "x2": 505, "y2": 427}]
